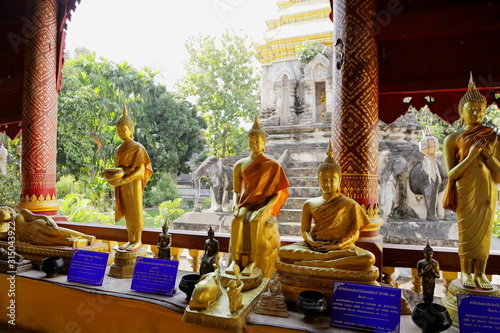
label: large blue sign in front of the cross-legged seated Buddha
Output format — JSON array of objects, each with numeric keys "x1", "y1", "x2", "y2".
[{"x1": 330, "y1": 281, "x2": 401, "y2": 332}]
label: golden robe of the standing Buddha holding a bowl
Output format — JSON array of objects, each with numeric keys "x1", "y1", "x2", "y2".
[{"x1": 115, "y1": 140, "x2": 153, "y2": 232}]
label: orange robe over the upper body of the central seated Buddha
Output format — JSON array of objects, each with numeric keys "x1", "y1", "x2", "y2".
[{"x1": 239, "y1": 154, "x2": 290, "y2": 216}]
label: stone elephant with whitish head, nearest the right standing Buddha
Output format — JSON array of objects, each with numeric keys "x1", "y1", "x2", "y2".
[{"x1": 409, "y1": 152, "x2": 448, "y2": 221}]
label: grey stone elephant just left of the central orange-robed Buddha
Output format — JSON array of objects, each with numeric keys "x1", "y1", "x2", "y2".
[{"x1": 192, "y1": 156, "x2": 233, "y2": 212}]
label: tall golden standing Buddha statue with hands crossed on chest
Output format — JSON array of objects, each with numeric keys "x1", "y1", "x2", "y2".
[{"x1": 443, "y1": 73, "x2": 500, "y2": 289}]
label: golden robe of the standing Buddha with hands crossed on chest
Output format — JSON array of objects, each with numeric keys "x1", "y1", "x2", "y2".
[{"x1": 443, "y1": 125, "x2": 500, "y2": 260}]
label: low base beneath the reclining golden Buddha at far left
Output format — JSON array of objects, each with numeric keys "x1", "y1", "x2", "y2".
[{"x1": 0, "y1": 241, "x2": 109, "y2": 274}]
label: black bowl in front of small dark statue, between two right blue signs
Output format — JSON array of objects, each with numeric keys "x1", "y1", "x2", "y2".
[{"x1": 411, "y1": 303, "x2": 452, "y2": 333}]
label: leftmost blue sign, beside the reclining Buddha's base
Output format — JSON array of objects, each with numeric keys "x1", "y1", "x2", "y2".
[{"x1": 68, "y1": 250, "x2": 109, "y2": 286}]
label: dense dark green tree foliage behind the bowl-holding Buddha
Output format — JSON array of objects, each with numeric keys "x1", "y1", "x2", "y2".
[{"x1": 57, "y1": 49, "x2": 205, "y2": 181}]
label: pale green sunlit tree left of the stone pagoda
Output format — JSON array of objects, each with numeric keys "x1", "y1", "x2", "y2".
[{"x1": 177, "y1": 31, "x2": 258, "y2": 158}]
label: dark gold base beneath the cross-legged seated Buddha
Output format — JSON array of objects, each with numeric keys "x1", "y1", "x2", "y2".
[{"x1": 276, "y1": 260, "x2": 380, "y2": 303}]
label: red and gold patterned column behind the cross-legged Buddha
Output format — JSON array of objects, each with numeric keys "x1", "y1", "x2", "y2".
[{"x1": 332, "y1": 0, "x2": 383, "y2": 240}]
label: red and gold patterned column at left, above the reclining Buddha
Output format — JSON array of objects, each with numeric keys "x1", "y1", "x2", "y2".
[{"x1": 17, "y1": 0, "x2": 59, "y2": 215}]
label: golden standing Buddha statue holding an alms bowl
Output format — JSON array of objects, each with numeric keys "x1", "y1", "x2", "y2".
[{"x1": 102, "y1": 107, "x2": 153, "y2": 251}]
